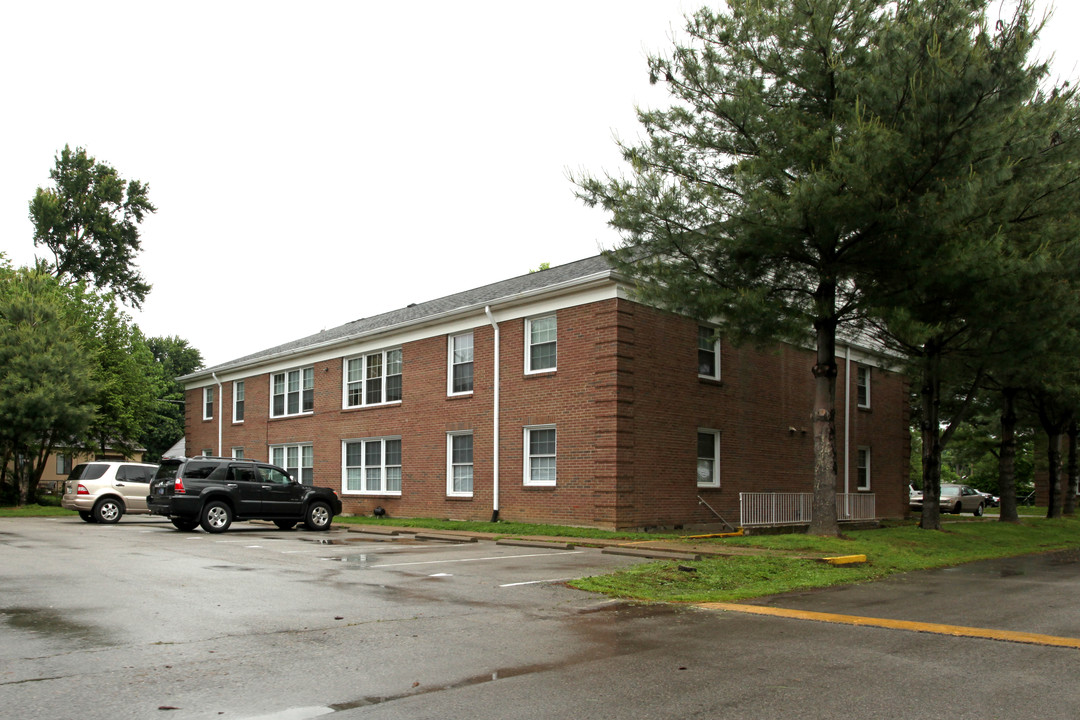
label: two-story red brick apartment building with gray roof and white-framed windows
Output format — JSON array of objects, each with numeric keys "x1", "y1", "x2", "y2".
[{"x1": 180, "y1": 256, "x2": 909, "y2": 528}]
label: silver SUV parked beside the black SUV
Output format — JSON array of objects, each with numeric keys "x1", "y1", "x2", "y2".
[{"x1": 60, "y1": 461, "x2": 158, "y2": 524}]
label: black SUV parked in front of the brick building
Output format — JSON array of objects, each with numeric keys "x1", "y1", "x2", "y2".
[{"x1": 146, "y1": 457, "x2": 341, "y2": 532}]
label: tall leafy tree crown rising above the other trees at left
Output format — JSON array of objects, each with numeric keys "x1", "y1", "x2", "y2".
[{"x1": 30, "y1": 146, "x2": 157, "y2": 308}]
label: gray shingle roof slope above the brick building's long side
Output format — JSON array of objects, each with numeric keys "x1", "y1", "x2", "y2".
[{"x1": 179, "y1": 255, "x2": 612, "y2": 381}]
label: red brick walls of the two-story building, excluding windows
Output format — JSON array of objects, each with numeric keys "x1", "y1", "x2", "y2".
[{"x1": 188, "y1": 300, "x2": 908, "y2": 527}]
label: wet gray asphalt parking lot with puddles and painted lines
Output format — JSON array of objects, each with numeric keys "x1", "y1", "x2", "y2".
[{"x1": 6, "y1": 517, "x2": 1080, "y2": 720}]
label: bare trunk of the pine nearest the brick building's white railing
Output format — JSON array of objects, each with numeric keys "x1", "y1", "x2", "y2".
[{"x1": 810, "y1": 310, "x2": 840, "y2": 536}]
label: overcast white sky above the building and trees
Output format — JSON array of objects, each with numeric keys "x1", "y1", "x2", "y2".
[{"x1": 0, "y1": 0, "x2": 1080, "y2": 366}]
